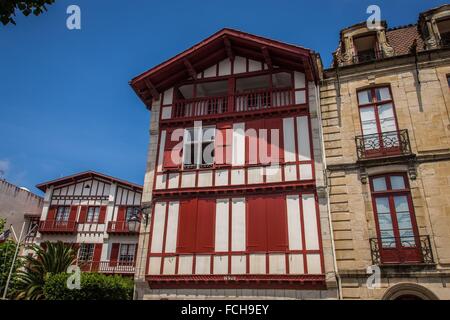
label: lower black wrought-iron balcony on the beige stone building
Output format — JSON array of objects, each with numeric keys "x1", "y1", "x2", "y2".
[{"x1": 370, "y1": 236, "x2": 434, "y2": 266}]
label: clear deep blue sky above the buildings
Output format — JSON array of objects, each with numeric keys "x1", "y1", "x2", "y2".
[{"x1": 0, "y1": 0, "x2": 446, "y2": 193}]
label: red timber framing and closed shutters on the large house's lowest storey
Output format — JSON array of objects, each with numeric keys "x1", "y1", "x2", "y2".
[{"x1": 146, "y1": 191, "x2": 325, "y2": 289}]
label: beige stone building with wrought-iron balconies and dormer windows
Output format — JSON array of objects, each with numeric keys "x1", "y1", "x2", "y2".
[{"x1": 320, "y1": 5, "x2": 450, "y2": 299}]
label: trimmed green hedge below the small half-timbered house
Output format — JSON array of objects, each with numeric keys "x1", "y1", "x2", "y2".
[{"x1": 44, "y1": 273, "x2": 133, "y2": 300}]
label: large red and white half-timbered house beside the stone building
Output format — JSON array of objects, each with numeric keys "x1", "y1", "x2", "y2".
[{"x1": 130, "y1": 29, "x2": 336, "y2": 299}]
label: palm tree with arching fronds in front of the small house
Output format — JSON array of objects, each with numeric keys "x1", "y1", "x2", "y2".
[{"x1": 16, "y1": 241, "x2": 77, "y2": 300}]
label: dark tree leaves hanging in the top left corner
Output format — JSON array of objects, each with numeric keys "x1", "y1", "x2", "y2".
[{"x1": 0, "y1": 0, "x2": 55, "y2": 25}]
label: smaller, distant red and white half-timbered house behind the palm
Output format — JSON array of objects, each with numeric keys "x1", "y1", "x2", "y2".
[{"x1": 35, "y1": 171, "x2": 142, "y2": 276}]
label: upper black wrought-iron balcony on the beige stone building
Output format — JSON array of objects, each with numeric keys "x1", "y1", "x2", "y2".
[{"x1": 355, "y1": 130, "x2": 412, "y2": 160}]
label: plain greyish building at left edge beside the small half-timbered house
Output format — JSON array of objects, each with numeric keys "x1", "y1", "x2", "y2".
[{"x1": 0, "y1": 180, "x2": 44, "y2": 242}]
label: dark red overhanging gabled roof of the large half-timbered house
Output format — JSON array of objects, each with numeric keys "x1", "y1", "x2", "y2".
[{"x1": 130, "y1": 28, "x2": 319, "y2": 108}]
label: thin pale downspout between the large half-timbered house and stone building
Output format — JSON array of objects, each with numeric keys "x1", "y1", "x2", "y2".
[{"x1": 316, "y1": 79, "x2": 342, "y2": 300}]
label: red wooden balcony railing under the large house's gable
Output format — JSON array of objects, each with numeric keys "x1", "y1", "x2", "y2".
[{"x1": 172, "y1": 89, "x2": 296, "y2": 119}]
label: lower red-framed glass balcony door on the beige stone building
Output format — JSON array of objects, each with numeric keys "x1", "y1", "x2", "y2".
[{"x1": 370, "y1": 174, "x2": 422, "y2": 264}]
